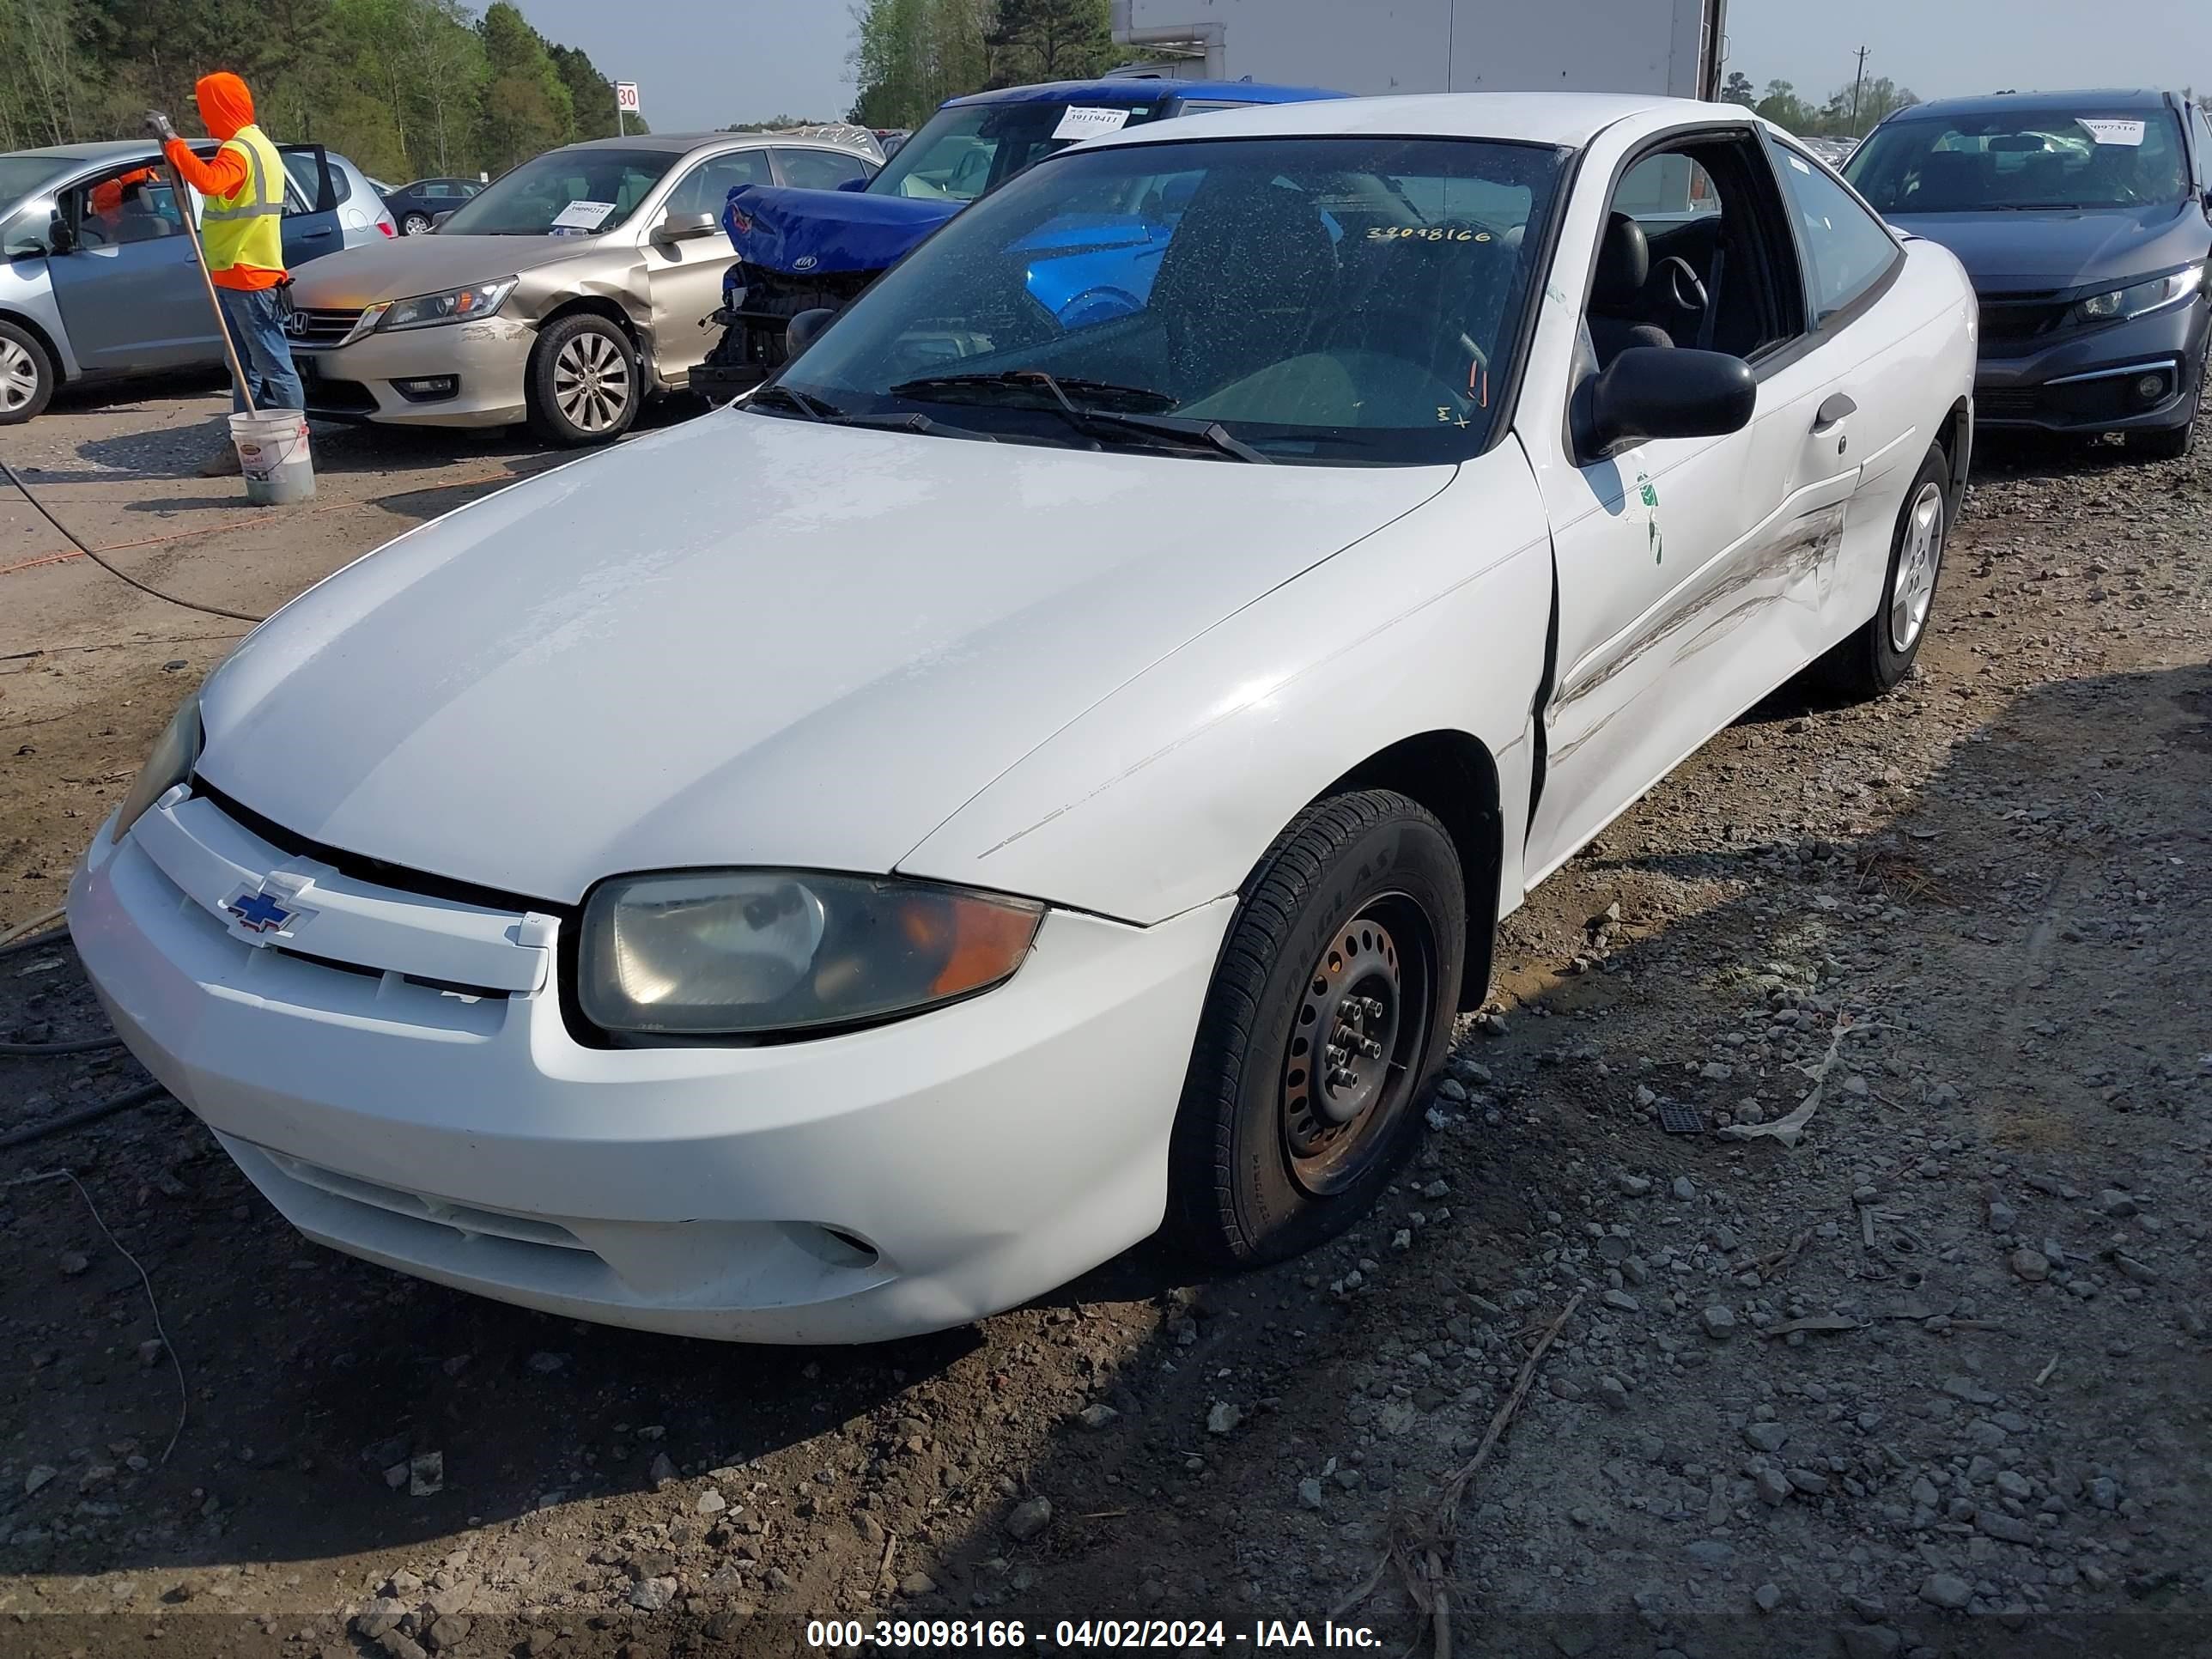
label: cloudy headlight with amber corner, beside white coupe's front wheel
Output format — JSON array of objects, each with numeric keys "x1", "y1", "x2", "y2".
[{"x1": 577, "y1": 869, "x2": 1044, "y2": 1037}]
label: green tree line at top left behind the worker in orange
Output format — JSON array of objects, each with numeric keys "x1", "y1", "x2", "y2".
[{"x1": 0, "y1": 0, "x2": 644, "y2": 184}]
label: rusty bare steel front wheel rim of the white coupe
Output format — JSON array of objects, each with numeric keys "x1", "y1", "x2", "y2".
[{"x1": 1276, "y1": 894, "x2": 1436, "y2": 1197}]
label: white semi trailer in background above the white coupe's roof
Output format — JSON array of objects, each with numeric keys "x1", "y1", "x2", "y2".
[{"x1": 1113, "y1": 0, "x2": 1728, "y2": 97}]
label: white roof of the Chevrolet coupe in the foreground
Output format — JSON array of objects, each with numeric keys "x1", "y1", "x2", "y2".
[{"x1": 1091, "y1": 93, "x2": 1690, "y2": 149}]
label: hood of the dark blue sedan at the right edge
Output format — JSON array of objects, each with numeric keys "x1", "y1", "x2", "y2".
[{"x1": 1891, "y1": 201, "x2": 2212, "y2": 295}]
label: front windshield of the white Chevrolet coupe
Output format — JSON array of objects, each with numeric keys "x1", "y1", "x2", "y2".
[{"x1": 778, "y1": 137, "x2": 1562, "y2": 465}]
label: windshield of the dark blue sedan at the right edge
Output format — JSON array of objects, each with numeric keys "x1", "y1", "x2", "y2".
[{"x1": 1843, "y1": 106, "x2": 2188, "y2": 215}]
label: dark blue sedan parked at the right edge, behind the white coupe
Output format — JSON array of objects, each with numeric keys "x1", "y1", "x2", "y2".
[{"x1": 1844, "y1": 91, "x2": 2212, "y2": 458}]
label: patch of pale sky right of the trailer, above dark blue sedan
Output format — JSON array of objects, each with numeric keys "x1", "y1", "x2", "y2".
[{"x1": 1728, "y1": 0, "x2": 2212, "y2": 101}]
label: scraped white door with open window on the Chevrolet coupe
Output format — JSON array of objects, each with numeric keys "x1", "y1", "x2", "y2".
[{"x1": 1516, "y1": 126, "x2": 1850, "y2": 883}]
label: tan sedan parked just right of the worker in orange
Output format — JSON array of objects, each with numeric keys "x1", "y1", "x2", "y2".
[{"x1": 289, "y1": 133, "x2": 880, "y2": 445}]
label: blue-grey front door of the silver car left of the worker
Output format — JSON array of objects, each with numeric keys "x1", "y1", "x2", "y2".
[{"x1": 46, "y1": 155, "x2": 223, "y2": 374}]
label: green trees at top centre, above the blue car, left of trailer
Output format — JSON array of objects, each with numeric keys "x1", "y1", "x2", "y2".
[{"x1": 849, "y1": 0, "x2": 1130, "y2": 126}]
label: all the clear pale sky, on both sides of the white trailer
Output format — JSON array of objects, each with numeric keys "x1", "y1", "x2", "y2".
[{"x1": 520, "y1": 0, "x2": 2212, "y2": 133}]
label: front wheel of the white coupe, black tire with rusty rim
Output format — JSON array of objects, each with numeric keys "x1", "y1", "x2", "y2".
[{"x1": 1168, "y1": 790, "x2": 1467, "y2": 1267}]
